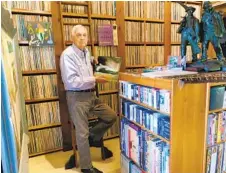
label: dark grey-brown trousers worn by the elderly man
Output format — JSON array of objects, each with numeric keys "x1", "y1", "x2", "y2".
[{"x1": 67, "y1": 91, "x2": 116, "y2": 169}]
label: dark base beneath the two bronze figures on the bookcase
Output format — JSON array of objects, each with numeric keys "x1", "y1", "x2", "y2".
[{"x1": 185, "y1": 59, "x2": 226, "y2": 72}]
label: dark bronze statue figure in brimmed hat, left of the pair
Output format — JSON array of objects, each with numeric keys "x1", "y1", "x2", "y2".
[{"x1": 177, "y1": 2, "x2": 201, "y2": 62}]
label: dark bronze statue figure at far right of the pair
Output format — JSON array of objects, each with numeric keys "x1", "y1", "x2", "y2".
[{"x1": 201, "y1": 1, "x2": 226, "y2": 64}]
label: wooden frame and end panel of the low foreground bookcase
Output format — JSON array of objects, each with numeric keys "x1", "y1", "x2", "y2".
[{"x1": 119, "y1": 73, "x2": 226, "y2": 173}]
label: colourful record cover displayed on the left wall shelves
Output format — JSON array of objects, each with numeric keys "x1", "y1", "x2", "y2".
[{"x1": 26, "y1": 22, "x2": 54, "y2": 46}]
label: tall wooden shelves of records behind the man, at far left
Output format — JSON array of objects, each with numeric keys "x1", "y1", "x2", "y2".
[{"x1": 7, "y1": 1, "x2": 62, "y2": 157}]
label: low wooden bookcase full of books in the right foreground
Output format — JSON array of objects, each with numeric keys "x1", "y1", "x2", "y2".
[{"x1": 119, "y1": 73, "x2": 226, "y2": 173}]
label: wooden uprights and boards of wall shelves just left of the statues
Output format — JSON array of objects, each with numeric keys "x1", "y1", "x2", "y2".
[{"x1": 118, "y1": 2, "x2": 170, "y2": 71}]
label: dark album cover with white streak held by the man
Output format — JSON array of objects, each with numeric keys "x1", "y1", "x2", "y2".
[{"x1": 95, "y1": 56, "x2": 122, "y2": 81}]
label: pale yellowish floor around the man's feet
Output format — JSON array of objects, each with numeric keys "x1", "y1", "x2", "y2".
[{"x1": 29, "y1": 138, "x2": 120, "y2": 173}]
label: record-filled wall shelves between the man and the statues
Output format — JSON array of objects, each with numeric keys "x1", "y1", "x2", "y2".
[{"x1": 116, "y1": 2, "x2": 170, "y2": 71}]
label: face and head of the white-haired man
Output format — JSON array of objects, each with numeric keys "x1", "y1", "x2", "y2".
[{"x1": 72, "y1": 27, "x2": 88, "y2": 49}]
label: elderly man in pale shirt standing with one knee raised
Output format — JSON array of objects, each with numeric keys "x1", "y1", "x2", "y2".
[{"x1": 60, "y1": 25, "x2": 116, "y2": 173}]
